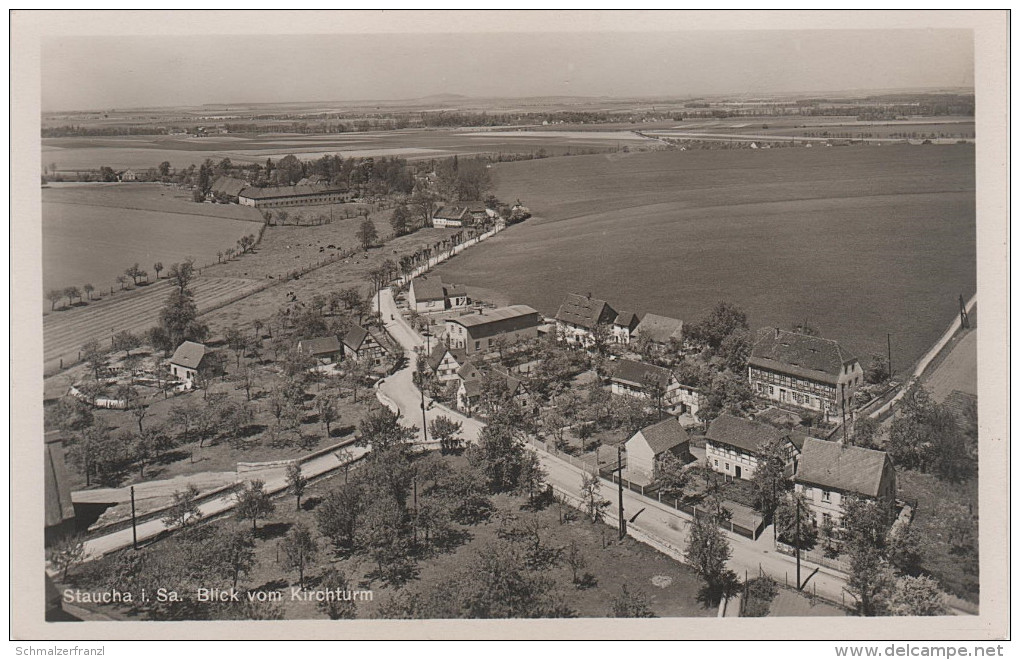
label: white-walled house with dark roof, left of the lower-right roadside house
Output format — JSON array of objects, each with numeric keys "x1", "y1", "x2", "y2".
[{"x1": 705, "y1": 414, "x2": 798, "y2": 479}]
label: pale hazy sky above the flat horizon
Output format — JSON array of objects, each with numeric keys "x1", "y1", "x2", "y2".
[{"x1": 41, "y1": 30, "x2": 974, "y2": 111}]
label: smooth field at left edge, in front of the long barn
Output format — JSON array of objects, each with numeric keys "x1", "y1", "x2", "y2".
[{"x1": 42, "y1": 184, "x2": 261, "y2": 292}]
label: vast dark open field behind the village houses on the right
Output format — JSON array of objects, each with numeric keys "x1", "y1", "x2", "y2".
[{"x1": 439, "y1": 145, "x2": 976, "y2": 364}]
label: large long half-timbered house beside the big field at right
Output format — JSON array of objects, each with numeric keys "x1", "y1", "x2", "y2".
[{"x1": 748, "y1": 327, "x2": 864, "y2": 419}]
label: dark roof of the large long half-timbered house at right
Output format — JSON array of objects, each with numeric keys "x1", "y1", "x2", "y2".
[{"x1": 748, "y1": 328, "x2": 857, "y2": 385}]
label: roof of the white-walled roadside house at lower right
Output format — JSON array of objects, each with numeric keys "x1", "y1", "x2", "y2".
[{"x1": 797, "y1": 438, "x2": 893, "y2": 497}]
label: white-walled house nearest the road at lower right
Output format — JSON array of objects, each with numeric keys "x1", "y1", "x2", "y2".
[{"x1": 794, "y1": 438, "x2": 896, "y2": 527}]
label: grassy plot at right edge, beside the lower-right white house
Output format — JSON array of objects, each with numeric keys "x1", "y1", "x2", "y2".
[{"x1": 897, "y1": 470, "x2": 980, "y2": 603}]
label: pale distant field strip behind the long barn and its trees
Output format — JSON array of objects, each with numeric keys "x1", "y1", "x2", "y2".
[{"x1": 41, "y1": 130, "x2": 640, "y2": 170}]
